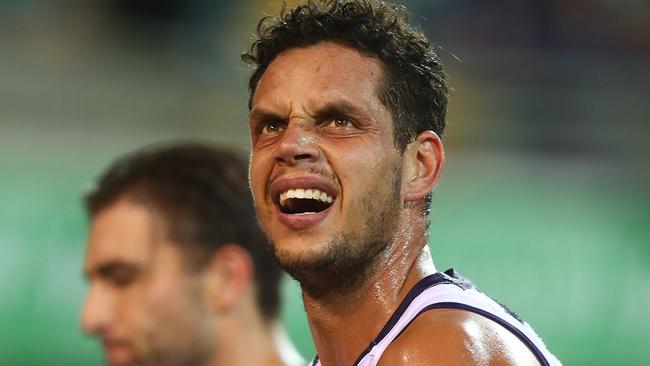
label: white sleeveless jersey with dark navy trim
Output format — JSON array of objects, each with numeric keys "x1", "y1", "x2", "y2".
[{"x1": 312, "y1": 269, "x2": 562, "y2": 366}]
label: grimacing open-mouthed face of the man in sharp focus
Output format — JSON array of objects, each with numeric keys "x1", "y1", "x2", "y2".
[{"x1": 249, "y1": 42, "x2": 402, "y2": 288}]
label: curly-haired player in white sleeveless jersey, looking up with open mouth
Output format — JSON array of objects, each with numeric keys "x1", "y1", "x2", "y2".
[{"x1": 243, "y1": 0, "x2": 559, "y2": 366}]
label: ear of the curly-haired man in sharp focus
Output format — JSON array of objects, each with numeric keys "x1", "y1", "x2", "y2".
[{"x1": 402, "y1": 131, "x2": 445, "y2": 202}]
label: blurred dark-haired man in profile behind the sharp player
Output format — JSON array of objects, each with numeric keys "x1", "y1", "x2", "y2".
[{"x1": 81, "y1": 144, "x2": 300, "y2": 366}]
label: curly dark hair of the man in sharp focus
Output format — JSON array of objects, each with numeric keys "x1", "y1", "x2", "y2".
[{"x1": 242, "y1": 0, "x2": 448, "y2": 151}]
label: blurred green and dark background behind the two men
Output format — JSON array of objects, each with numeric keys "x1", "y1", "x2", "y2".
[{"x1": 0, "y1": 0, "x2": 650, "y2": 365}]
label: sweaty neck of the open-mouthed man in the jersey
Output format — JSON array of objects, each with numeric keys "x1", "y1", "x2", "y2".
[{"x1": 303, "y1": 222, "x2": 436, "y2": 365}]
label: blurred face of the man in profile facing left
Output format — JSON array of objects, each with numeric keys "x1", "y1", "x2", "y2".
[{"x1": 81, "y1": 199, "x2": 214, "y2": 365}]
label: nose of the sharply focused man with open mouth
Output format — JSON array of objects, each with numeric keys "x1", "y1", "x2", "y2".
[{"x1": 275, "y1": 122, "x2": 321, "y2": 166}]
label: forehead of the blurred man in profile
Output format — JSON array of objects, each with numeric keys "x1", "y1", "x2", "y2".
[{"x1": 86, "y1": 199, "x2": 164, "y2": 270}]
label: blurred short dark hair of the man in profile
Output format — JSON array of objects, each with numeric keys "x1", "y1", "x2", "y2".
[{"x1": 85, "y1": 143, "x2": 282, "y2": 320}]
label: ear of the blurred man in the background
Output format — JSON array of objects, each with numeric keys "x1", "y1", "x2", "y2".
[{"x1": 203, "y1": 244, "x2": 254, "y2": 313}]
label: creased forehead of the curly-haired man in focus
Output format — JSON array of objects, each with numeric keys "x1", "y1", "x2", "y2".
[{"x1": 253, "y1": 42, "x2": 383, "y2": 107}]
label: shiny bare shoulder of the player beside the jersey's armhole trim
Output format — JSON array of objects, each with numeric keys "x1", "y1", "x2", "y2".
[{"x1": 379, "y1": 309, "x2": 539, "y2": 366}]
